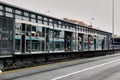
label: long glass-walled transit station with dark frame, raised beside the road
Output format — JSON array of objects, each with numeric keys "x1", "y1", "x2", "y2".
[{"x1": 0, "y1": 2, "x2": 117, "y2": 69}]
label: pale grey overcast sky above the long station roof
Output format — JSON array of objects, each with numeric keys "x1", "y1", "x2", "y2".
[{"x1": 0, "y1": 0, "x2": 120, "y2": 36}]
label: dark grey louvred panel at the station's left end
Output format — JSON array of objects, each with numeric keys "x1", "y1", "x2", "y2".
[{"x1": 0, "y1": 16, "x2": 14, "y2": 55}]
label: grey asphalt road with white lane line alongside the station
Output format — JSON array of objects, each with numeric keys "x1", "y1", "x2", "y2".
[{"x1": 0, "y1": 54, "x2": 120, "y2": 80}]
